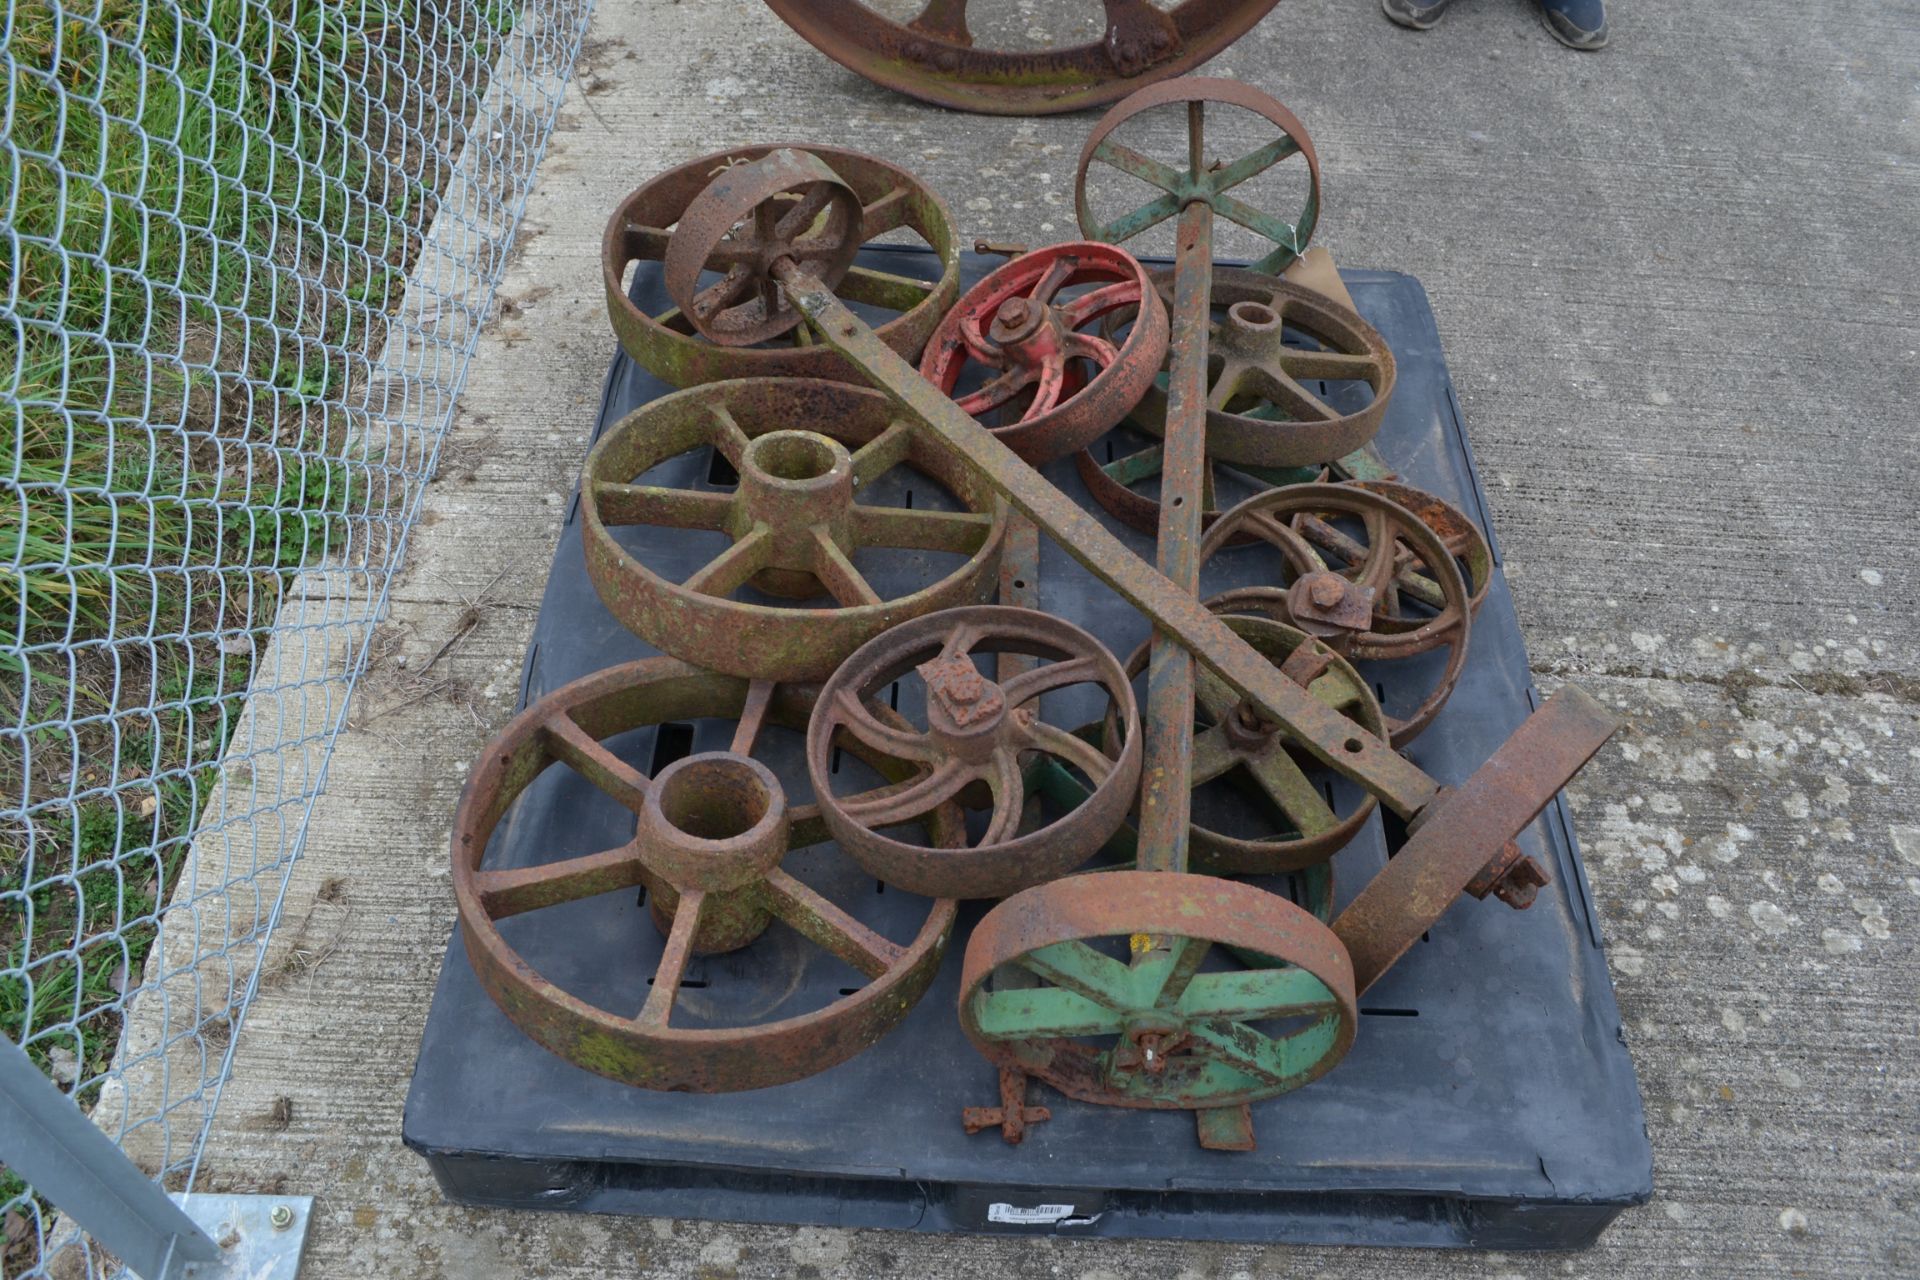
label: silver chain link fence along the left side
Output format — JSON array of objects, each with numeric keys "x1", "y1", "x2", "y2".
[{"x1": 0, "y1": 0, "x2": 591, "y2": 1276}]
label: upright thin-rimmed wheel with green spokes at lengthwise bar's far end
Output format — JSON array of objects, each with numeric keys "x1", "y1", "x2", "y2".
[{"x1": 1073, "y1": 77, "x2": 1319, "y2": 276}]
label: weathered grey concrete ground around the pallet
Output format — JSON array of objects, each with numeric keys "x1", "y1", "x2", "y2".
[{"x1": 176, "y1": 0, "x2": 1920, "y2": 1280}]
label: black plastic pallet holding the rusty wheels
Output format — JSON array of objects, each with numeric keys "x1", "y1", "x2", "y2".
[{"x1": 403, "y1": 249, "x2": 1653, "y2": 1249}]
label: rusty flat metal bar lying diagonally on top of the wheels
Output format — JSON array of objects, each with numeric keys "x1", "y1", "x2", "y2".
[{"x1": 772, "y1": 259, "x2": 1440, "y2": 816}]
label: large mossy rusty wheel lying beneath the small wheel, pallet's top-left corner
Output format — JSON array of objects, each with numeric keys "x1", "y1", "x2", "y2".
[{"x1": 601, "y1": 144, "x2": 960, "y2": 388}]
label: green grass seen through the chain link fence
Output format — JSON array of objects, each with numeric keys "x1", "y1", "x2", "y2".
[{"x1": 0, "y1": 0, "x2": 518, "y2": 1272}]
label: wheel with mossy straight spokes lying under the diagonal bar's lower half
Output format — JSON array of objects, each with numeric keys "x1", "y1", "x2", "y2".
[{"x1": 1104, "y1": 618, "x2": 1386, "y2": 875}]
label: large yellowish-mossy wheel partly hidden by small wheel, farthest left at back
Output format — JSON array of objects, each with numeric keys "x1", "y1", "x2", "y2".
[{"x1": 601, "y1": 144, "x2": 960, "y2": 388}]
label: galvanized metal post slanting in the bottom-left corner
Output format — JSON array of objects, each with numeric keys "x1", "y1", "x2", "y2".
[{"x1": 0, "y1": 1038, "x2": 221, "y2": 1280}]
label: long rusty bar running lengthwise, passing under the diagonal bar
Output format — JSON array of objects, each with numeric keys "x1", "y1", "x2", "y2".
[{"x1": 1139, "y1": 185, "x2": 1213, "y2": 871}]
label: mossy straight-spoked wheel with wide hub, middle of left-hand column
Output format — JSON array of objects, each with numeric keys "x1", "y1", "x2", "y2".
[{"x1": 580, "y1": 378, "x2": 1006, "y2": 679}]
